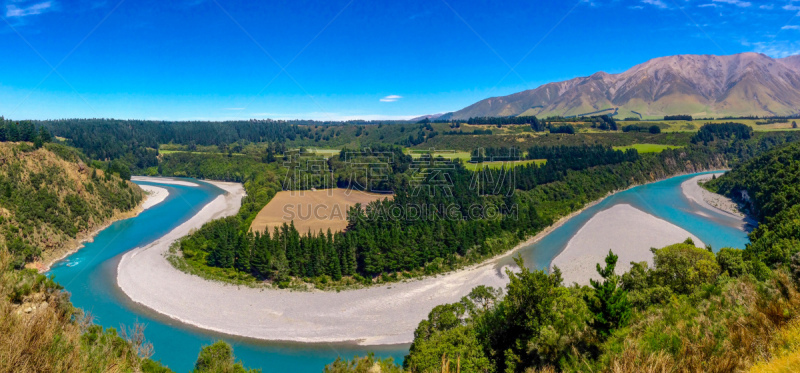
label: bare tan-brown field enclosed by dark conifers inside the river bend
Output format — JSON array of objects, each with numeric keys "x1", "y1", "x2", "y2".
[{"x1": 250, "y1": 189, "x2": 392, "y2": 234}]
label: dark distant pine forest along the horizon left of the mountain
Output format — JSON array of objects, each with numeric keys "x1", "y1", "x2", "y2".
[{"x1": 35, "y1": 119, "x2": 412, "y2": 170}]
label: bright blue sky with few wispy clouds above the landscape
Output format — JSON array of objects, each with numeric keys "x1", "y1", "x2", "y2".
[{"x1": 0, "y1": 0, "x2": 800, "y2": 120}]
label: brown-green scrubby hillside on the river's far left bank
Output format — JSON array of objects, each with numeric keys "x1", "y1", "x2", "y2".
[{"x1": 0, "y1": 142, "x2": 143, "y2": 267}]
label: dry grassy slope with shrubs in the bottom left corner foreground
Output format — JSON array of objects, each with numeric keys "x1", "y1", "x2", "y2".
[{"x1": 0, "y1": 248, "x2": 168, "y2": 373}]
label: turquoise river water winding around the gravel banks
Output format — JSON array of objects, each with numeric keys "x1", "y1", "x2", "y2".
[{"x1": 48, "y1": 171, "x2": 748, "y2": 372}]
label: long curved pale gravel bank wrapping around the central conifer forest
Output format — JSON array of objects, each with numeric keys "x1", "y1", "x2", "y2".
[{"x1": 112, "y1": 170, "x2": 732, "y2": 345}]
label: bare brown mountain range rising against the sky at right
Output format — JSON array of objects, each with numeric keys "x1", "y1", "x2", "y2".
[{"x1": 439, "y1": 53, "x2": 800, "y2": 119}]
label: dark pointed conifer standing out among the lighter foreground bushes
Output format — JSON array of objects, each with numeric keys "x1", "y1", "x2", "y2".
[{"x1": 586, "y1": 250, "x2": 631, "y2": 338}]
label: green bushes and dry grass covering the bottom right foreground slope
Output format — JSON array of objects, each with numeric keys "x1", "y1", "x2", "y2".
[{"x1": 404, "y1": 235, "x2": 800, "y2": 372}]
